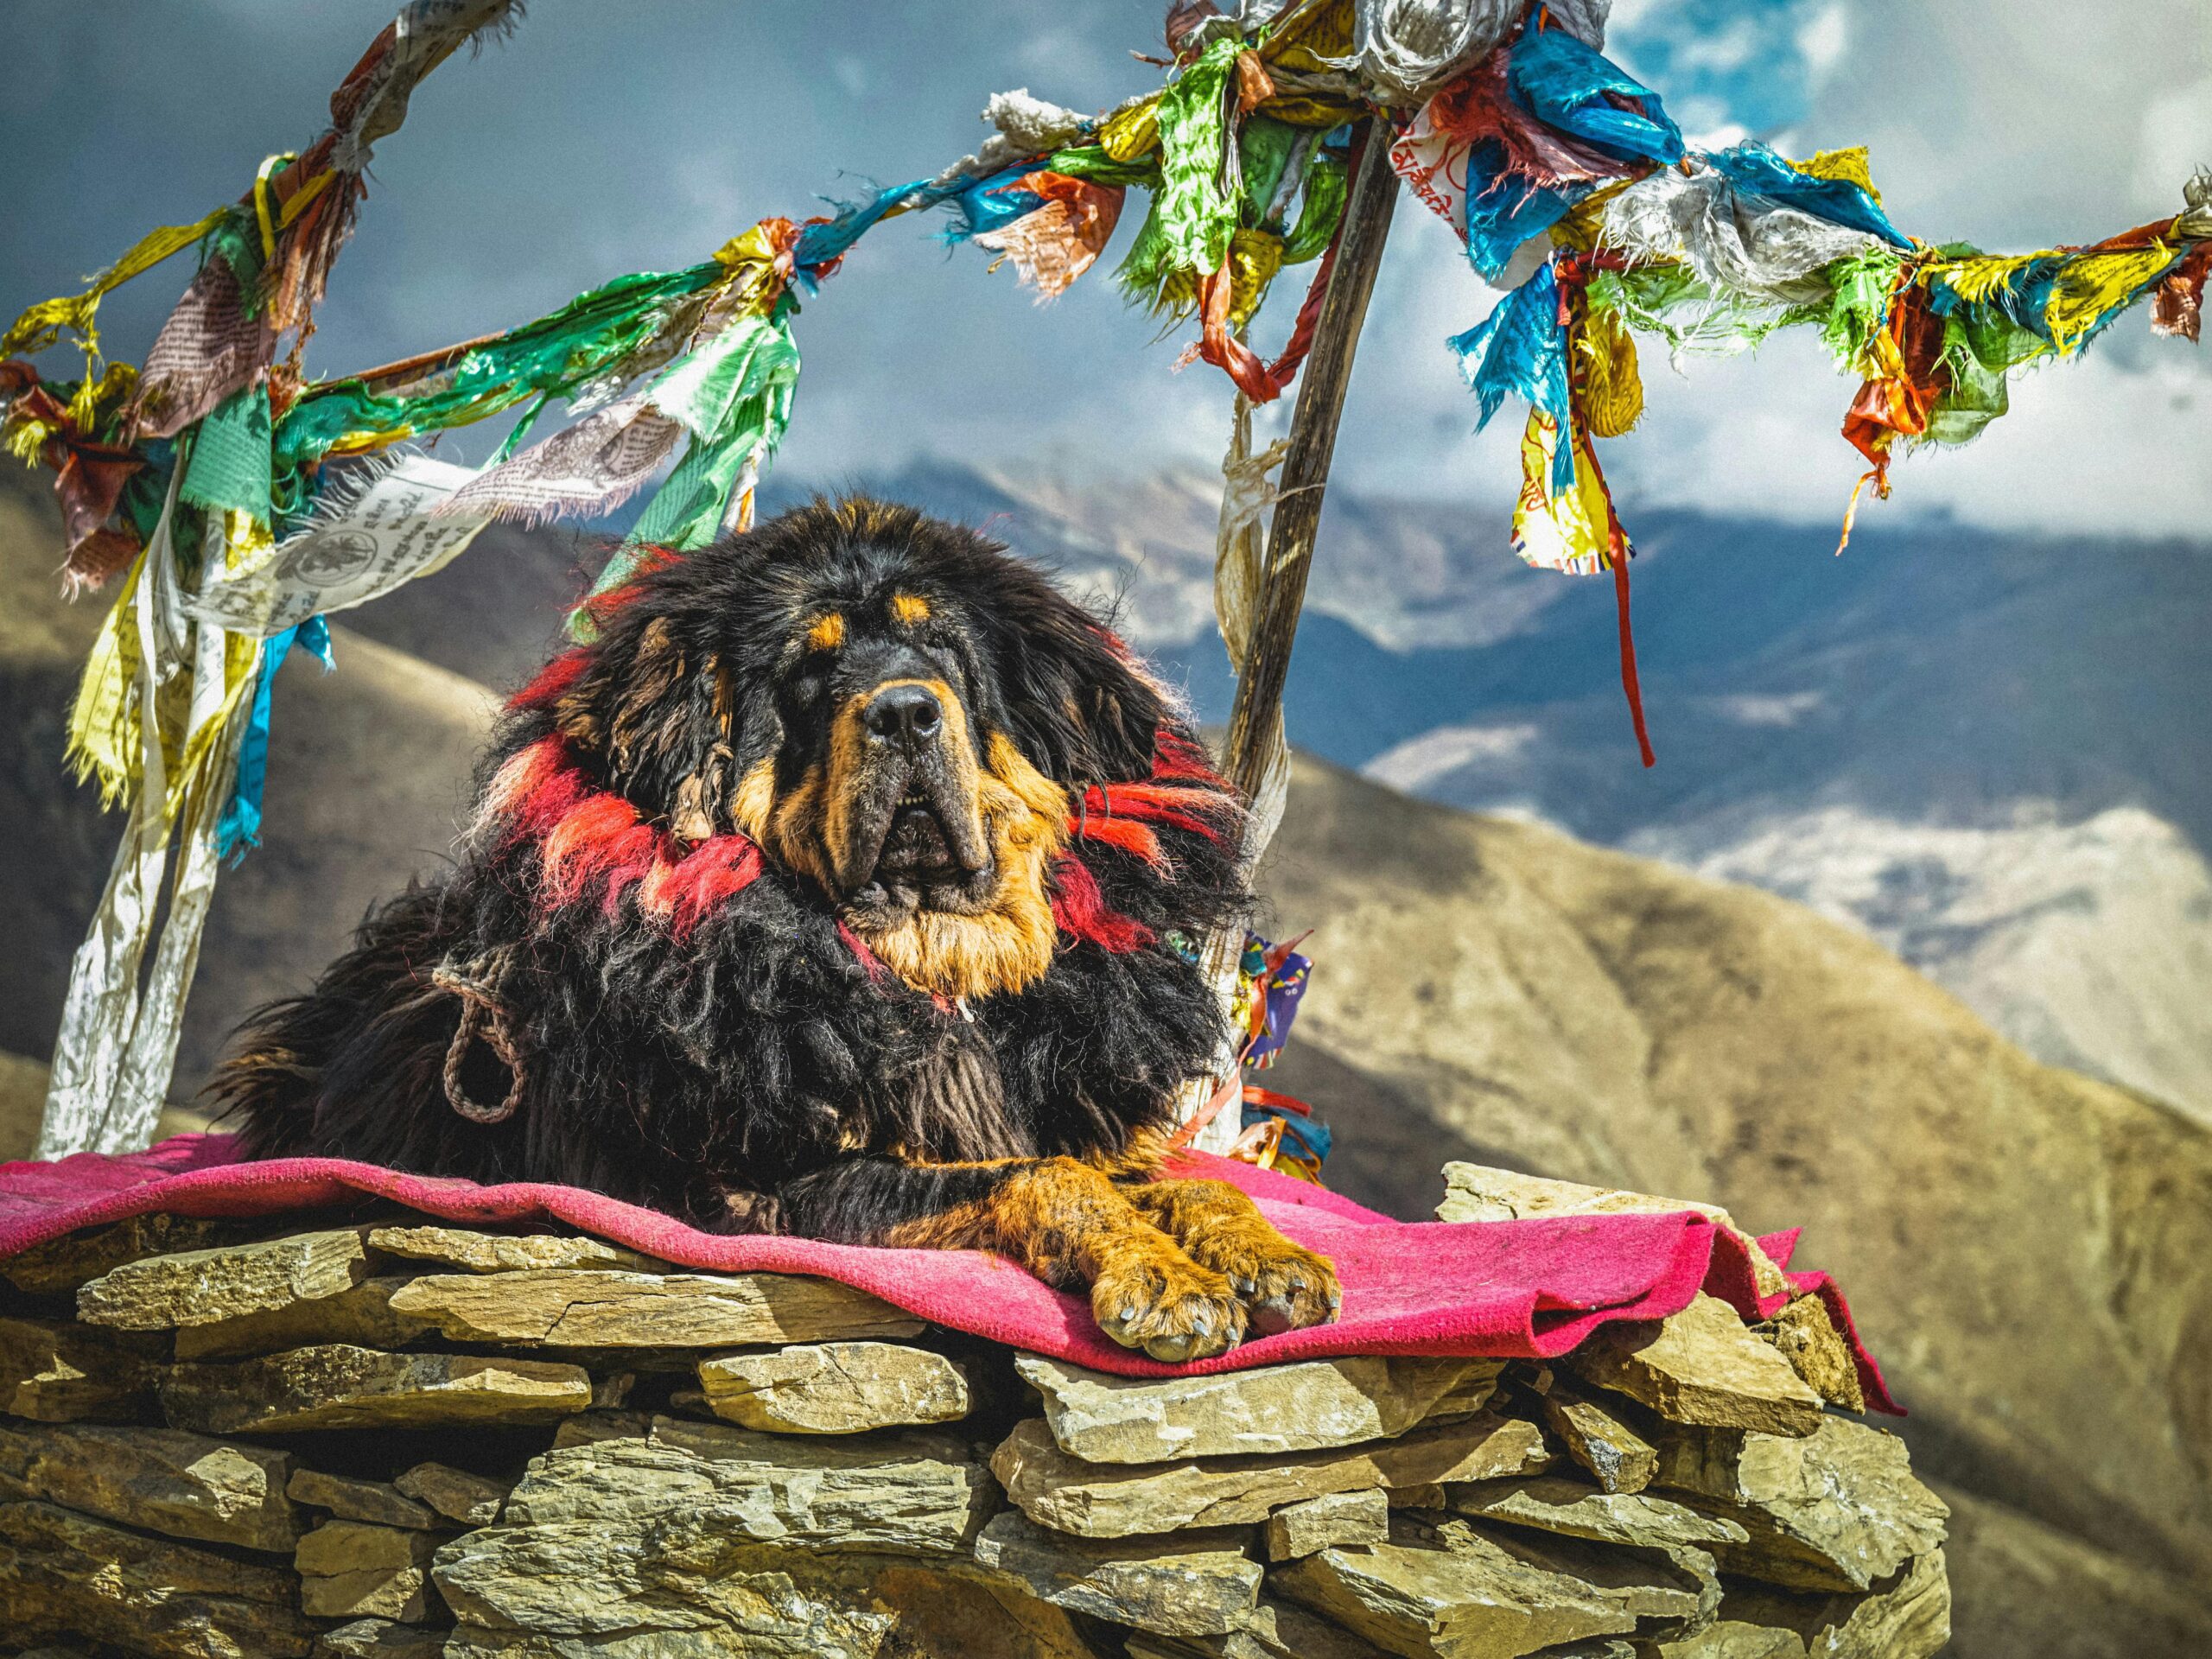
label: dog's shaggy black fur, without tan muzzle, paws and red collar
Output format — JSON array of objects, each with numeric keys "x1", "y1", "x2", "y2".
[{"x1": 210, "y1": 502, "x2": 1249, "y2": 1239}]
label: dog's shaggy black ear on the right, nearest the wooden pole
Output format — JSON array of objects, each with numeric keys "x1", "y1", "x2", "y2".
[{"x1": 980, "y1": 580, "x2": 1181, "y2": 783}]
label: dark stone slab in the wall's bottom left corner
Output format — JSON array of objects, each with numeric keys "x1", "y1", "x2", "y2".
[{"x1": 0, "y1": 1502, "x2": 315, "y2": 1659}]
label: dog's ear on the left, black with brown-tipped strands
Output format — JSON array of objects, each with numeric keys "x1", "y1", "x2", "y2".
[{"x1": 553, "y1": 617, "x2": 781, "y2": 841}]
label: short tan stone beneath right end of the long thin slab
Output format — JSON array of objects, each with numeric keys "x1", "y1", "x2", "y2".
[{"x1": 699, "y1": 1343, "x2": 969, "y2": 1433}]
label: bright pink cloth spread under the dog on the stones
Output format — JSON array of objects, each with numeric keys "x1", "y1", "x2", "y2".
[{"x1": 0, "y1": 1135, "x2": 1896, "y2": 1411}]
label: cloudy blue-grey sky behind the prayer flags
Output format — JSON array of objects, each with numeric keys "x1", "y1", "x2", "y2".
[{"x1": 13, "y1": 0, "x2": 2212, "y2": 536}]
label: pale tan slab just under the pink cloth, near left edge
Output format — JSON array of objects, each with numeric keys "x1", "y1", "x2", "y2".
[{"x1": 78, "y1": 1228, "x2": 370, "y2": 1332}]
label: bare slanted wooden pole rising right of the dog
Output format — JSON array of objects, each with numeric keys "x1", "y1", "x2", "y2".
[{"x1": 1228, "y1": 119, "x2": 1398, "y2": 814}]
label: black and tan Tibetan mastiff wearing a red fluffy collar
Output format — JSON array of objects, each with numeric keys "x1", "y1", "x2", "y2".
[{"x1": 210, "y1": 498, "x2": 1338, "y2": 1360}]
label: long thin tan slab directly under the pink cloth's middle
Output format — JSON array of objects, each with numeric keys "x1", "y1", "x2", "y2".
[{"x1": 391, "y1": 1268, "x2": 923, "y2": 1347}]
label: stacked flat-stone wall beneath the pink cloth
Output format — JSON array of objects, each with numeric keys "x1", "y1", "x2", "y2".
[{"x1": 0, "y1": 1166, "x2": 1948, "y2": 1659}]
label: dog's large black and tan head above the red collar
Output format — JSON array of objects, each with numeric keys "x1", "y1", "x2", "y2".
[{"x1": 499, "y1": 500, "x2": 1221, "y2": 998}]
